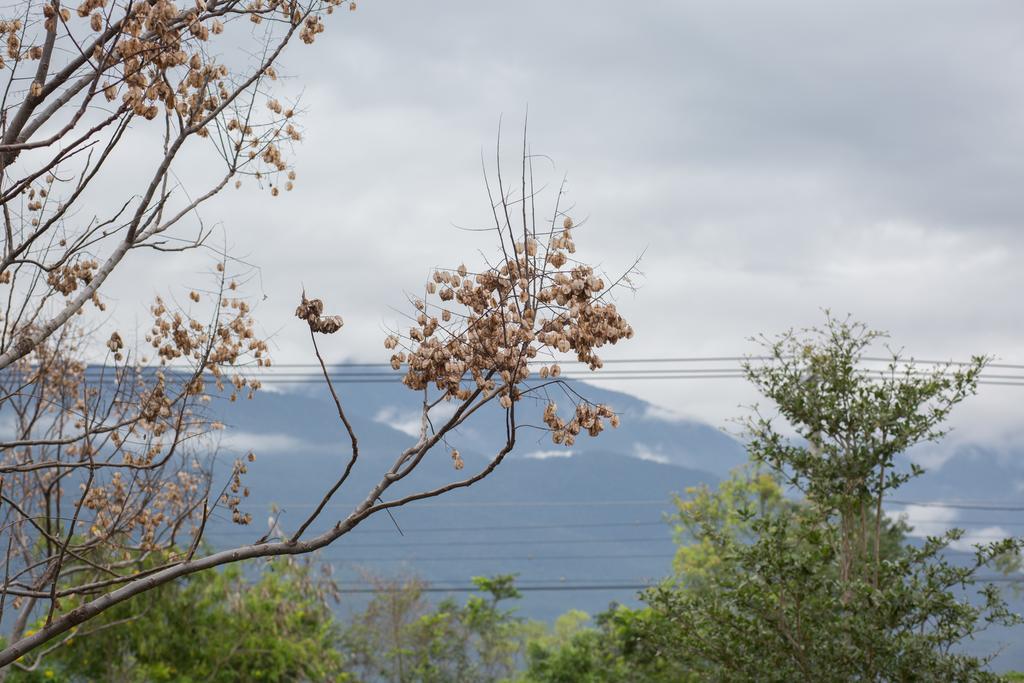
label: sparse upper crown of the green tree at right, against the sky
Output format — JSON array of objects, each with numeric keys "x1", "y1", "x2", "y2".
[{"x1": 744, "y1": 316, "x2": 985, "y2": 520}]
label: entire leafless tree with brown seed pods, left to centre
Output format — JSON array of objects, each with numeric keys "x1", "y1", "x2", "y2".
[{"x1": 0, "y1": 0, "x2": 632, "y2": 677}]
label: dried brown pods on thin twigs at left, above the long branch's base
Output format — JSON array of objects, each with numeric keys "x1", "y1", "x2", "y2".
[{"x1": 0, "y1": 285, "x2": 269, "y2": 589}]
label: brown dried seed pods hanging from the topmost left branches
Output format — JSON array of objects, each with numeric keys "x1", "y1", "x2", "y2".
[{"x1": 0, "y1": 0, "x2": 355, "y2": 205}]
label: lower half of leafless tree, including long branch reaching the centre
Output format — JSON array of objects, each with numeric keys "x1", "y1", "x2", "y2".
[{"x1": 0, "y1": 132, "x2": 633, "y2": 667}]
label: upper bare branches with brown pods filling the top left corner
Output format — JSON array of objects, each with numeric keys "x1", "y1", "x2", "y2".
[{"x1": 0, "y1": 0, "x2": 344, "y2": 369}]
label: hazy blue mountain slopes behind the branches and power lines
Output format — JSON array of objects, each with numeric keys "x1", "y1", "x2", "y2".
[{"x1": 197, "y1": 374, "x2": 1024, "y2": 668}]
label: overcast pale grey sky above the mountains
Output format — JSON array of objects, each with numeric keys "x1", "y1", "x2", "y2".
[{"x1": 108, "y1": 0, "x2": 1024, "y2": 458}]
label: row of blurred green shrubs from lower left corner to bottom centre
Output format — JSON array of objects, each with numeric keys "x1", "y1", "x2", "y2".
[{"x1": 8, "y1": 573, "x2": 542, "y2": 683}]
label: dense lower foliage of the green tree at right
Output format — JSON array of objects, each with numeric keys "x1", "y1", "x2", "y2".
[{"x1": 644, "y1": 507, "x2": 1016, "y2": 681}]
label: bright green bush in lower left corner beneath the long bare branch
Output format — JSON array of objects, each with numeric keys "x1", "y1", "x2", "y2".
[{"x1": 8, "y1": 559, "x2": 350, "y2": 683}]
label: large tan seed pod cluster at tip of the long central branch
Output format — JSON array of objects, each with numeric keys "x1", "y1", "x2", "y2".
[{"x1": 384, "y1": 217, "x2": 633, "y2": 444}]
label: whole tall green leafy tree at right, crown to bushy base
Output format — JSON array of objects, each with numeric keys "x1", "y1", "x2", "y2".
[{"x1": 642, "y1": 317, "x2": 1020, "y2": 681}]
